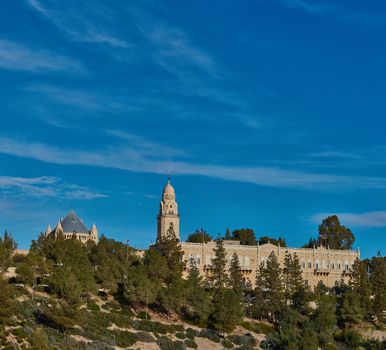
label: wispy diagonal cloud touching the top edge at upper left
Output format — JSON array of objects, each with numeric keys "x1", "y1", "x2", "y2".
[{"x1": 27, "y1": 0, "x2": 129, "y2": 48}]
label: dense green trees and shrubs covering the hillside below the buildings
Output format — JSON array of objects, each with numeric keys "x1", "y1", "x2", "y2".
[{"x1": 0, "y1": 217, "x2": 386, "y2": 350}]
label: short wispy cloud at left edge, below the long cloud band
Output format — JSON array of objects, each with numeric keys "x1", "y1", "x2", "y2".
[{"x1": 0, "y1": 176, "x2": 107, "y2": 200}]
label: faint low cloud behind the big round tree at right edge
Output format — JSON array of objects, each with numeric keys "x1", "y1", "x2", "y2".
[{"x1": 310, "y1": 211, "x2": 386, "y2": 227}]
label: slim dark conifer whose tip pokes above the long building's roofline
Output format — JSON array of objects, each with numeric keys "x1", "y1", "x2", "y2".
[{"x1": 209, "y1": 238, "x2": 228, "y2": 292}]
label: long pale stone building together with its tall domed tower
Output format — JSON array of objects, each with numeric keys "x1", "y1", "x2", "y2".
[{"x1": 157, "y1": 181, "x2": 360, "y2": 287}]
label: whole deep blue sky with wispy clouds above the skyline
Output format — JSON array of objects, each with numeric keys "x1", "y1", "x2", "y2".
[{"x1": 0, "y1": 0, "x2": 386, "y2": 256}]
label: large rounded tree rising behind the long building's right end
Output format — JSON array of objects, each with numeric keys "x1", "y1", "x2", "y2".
[{"x1": 318, "y1": 215, "x2": 355, "y2": 249}]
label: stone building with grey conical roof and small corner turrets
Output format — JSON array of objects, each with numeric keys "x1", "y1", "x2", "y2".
[{"x1": 45, "y1": 210, "x2": 99, "y2": 243}]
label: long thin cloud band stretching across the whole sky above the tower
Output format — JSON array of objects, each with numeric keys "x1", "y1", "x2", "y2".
[{"x1": 0, "y1": 137, "x2": 386, "y2": 191}]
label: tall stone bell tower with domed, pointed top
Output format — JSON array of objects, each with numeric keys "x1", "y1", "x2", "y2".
[{"x1": 157, "y1": 179, "x2": 180, "y2": 240}]
